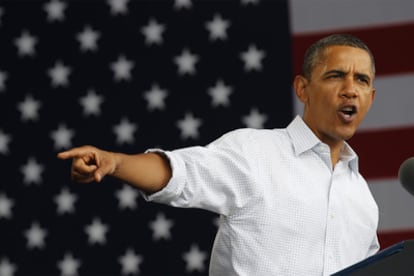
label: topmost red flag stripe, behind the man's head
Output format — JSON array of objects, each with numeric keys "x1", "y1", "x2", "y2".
[{"x1": 292, "y1": 23, "x2": 414, "y2": 75}]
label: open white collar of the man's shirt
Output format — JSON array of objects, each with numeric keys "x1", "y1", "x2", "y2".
[{"x1": 287, "y1": 115, "x2": 358, "y2": 173}]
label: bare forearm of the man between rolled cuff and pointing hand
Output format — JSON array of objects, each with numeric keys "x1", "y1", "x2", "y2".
[{"x1": 111, "y1": 153, "x2": 172, "y2": 193}]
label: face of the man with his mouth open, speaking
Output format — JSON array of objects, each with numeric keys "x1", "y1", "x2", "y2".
[{"x1": 294, "y1": 46, "x2": 375, "y2": 145}]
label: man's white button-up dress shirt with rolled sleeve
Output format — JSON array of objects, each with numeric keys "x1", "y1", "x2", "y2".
[{"x1": 147, "y1": 116, "x2": 379, "y2": 276}]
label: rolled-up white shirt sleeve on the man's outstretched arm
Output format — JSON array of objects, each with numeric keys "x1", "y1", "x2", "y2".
[{"x1": 144, "y1": 131, "x2": 258, "y2": 215}]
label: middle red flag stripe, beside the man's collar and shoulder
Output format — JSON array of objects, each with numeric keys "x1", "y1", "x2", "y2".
[{"x1": 349, "y1": 127, "x2": 414, "y2": 179}]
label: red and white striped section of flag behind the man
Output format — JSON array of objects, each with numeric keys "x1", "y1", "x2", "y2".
[{"x1": 289, "y1": 0, "x2": 414, "y2": 251}]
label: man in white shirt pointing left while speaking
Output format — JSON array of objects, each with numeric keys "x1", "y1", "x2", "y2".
[{"x1": 58, "y1": 35, "x2": 379, "y2": 276}]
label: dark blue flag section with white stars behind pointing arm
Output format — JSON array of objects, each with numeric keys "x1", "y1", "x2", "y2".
[{"x1": 0, "y1": 0, "x2": 293, "y2": 276}]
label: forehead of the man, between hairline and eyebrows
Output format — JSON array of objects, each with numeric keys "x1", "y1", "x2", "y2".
[{"x1": 315, "y1": 45, "x2": 373, "y2": 75}]
